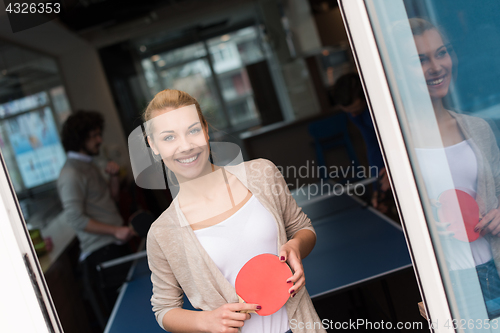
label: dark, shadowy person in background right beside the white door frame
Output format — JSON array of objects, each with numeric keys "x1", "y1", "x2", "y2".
[{"x1": 332, "y1": 73, "x2": 392, "y2": 213}]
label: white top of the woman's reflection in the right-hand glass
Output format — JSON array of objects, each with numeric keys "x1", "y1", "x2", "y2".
[{"x1": 415, "y1": 140, "x2": 493, "y2": 270}]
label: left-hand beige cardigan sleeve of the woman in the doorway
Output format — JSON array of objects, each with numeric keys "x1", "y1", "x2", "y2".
[{"x1": 146, "y1": 231, "x2": 184, "y2": 329}]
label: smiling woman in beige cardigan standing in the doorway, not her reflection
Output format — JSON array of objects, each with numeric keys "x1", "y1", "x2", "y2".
[{"x1": 144, "y1": 90, "x2": 325, "y2": 333}]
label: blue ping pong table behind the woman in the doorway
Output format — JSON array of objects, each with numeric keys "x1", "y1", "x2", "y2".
[{"x1": 105, "y1": 187, "x2": 412, "y2": 333}]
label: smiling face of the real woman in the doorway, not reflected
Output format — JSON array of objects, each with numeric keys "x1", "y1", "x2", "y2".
[{"x1": 148, "y1": 105, "x2": 209, "y2": 181}]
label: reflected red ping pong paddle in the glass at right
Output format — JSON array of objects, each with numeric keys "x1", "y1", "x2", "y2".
[{"x1": 438, "y1": 189, "x2": 480, "y2": 242}]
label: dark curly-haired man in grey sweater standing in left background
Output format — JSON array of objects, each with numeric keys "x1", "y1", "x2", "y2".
[{"x1": 57, "y1": 111, "x2": 133, "y2": 312}]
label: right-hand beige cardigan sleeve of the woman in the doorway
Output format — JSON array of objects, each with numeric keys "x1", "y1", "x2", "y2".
[{"x1": 264, "y1": 160, "x2": 316, "y2": 239}]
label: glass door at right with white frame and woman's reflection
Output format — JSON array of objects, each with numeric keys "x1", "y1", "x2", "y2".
[{"x1": 339, "y1": 0, "x2": 500, "y2": 332}]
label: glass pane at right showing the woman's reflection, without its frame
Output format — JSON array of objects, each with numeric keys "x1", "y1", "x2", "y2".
[{"x1": 365, "y1": 0, "x2": 500, "y2": 324}]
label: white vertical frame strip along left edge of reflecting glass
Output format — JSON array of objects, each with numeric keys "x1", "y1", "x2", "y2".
[{"x1": 339, "y1": 0, "x2": 454, "y2": 332}]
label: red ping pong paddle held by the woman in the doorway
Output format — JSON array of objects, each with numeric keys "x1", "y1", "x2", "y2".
[{"x1": 235, "y1": 253, "x2": 293, "y2": 316}]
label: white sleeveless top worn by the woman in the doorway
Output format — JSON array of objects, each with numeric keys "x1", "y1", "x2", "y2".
[{"x1": 194, "y1": 195, "x2": 289, "y2": 333}]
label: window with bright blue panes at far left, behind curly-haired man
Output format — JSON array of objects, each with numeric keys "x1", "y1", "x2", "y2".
[{"x1": 0, "y1": 43, "x2": 71, "y2": 197}]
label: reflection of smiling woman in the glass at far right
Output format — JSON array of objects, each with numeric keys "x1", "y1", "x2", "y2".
[{"x1": 410, "y1": 18, "x2": 500, "y2": 319}]
